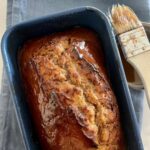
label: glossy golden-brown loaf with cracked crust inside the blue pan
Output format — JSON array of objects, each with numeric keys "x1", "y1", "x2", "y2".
[{"x1": 19, "y1": 28, "x2": 124, "y2": 150}]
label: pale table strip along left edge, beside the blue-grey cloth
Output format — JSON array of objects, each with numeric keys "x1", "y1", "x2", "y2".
[{"x1": 0, "y1": 0, "x2": 7, "y2": 90}]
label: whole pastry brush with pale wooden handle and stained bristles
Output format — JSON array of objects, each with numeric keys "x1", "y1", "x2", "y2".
[{"x1": 108, "y1": 4, "x2": 150, "y2": 107}]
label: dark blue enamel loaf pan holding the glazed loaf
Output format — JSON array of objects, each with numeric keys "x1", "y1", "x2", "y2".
[{"x1": 2, "y1": 7, "x2": 143, "y2": 150}]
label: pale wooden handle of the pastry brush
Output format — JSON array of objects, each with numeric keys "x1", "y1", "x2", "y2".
[{"x1": 127, "y1": 50, "x2": 150, "y2": 108}]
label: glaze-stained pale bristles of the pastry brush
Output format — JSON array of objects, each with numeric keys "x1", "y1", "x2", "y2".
[{"x1": 108, "y1": 4, "x2": 142, "y2": 34}]
